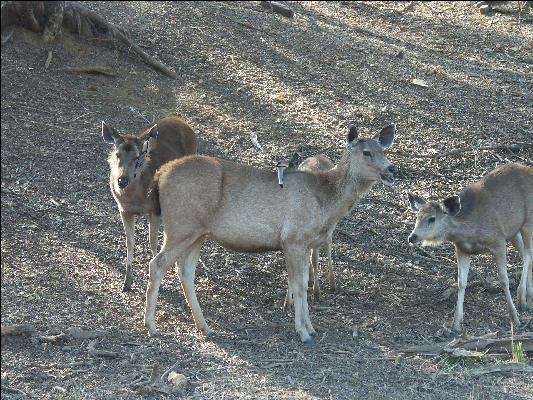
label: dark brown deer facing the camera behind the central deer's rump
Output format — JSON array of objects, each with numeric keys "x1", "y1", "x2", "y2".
[{"x1": 102, "y1": 117, "x2": 197, "y2": 291}]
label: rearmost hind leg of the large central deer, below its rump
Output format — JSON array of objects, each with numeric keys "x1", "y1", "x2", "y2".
[{"x1": 144, "y1": 238, "x2": 198, "y2": 337}]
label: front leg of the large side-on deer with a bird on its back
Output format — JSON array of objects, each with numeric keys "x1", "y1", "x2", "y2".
[{"x1": 284, "y1": 248, "x2": 315, "y2": 344}]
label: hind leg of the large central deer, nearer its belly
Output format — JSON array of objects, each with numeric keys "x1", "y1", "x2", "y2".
[{"x1": 178, "y1": 237, "x2": 212, "y2": 336}]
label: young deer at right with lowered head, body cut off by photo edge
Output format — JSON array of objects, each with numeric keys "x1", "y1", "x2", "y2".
[{"x1": 407, "y1": 163, "x2": 533, "y2": 335}]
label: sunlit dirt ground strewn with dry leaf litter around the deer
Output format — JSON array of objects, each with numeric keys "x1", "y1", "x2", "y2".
[{"x1": 1, "y1": 1, "x2": 533, "y2": 399}]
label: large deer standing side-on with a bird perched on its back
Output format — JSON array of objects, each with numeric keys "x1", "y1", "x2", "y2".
[{"x1": 144, "y1": 124, "x2": 397, "y2": 344}]
